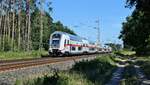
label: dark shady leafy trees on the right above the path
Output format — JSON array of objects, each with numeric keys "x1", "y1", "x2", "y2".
[{"x1": 119, "y1": 0, "x2": 150, "y2": 55}]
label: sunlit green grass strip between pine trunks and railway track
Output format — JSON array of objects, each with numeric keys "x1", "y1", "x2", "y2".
[{"x1": 0, "y1": 51, "x2": 48, "y2": 60}]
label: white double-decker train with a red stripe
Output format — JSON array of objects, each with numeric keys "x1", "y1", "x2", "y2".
[{"x1": 49, "y1": 31, "x2": 111, "y2": 56}]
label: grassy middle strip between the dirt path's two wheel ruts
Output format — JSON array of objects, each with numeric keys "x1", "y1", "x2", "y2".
[{"x1": 115, "y1": 50, "x2": 140, "y2": 85}]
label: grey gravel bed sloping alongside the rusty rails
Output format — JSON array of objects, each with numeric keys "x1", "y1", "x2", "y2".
[{"x1": 0, "y1": 56, "x2": 96, "y2": 85}]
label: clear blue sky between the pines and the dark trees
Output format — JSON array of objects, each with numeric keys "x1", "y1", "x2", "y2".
[{"x1": 47, "y1": 0, "x2": 132, "y2": 43}]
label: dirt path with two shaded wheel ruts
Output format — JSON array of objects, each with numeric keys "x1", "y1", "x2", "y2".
[{"x1": 106, "y1": 58, "x2": 150, "y2": 85}]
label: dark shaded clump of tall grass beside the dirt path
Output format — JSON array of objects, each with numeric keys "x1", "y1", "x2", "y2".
[{"x1": 72, "y1": 56, "x2": 115, "y2": 85}]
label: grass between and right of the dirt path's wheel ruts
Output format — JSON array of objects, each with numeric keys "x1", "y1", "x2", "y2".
[{"x1": 115, "y1": 51, "x2": 150, "y2": 85}]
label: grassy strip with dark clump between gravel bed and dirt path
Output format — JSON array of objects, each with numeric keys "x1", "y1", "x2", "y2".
[{"x1": 16, "y1": 56, "x2": 116, "y2": 85}]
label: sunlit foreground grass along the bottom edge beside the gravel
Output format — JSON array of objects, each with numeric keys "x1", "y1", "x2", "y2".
[{"x1": 15, "y1": 72, "x2": 94, "y2": 85}]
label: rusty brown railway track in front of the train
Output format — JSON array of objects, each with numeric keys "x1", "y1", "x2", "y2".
[{"x1": 0, "y1": 54, "x2": 97, "y2": 72}]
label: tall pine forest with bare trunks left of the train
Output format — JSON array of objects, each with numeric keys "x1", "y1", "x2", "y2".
[{"x1": 0, "y1": 0, "x2": 75, "y2": 51}]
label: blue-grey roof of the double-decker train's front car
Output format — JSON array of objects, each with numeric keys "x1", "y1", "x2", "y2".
[{"x1": 53, "y1": 31, "x2": 86, "y2": 42}]
